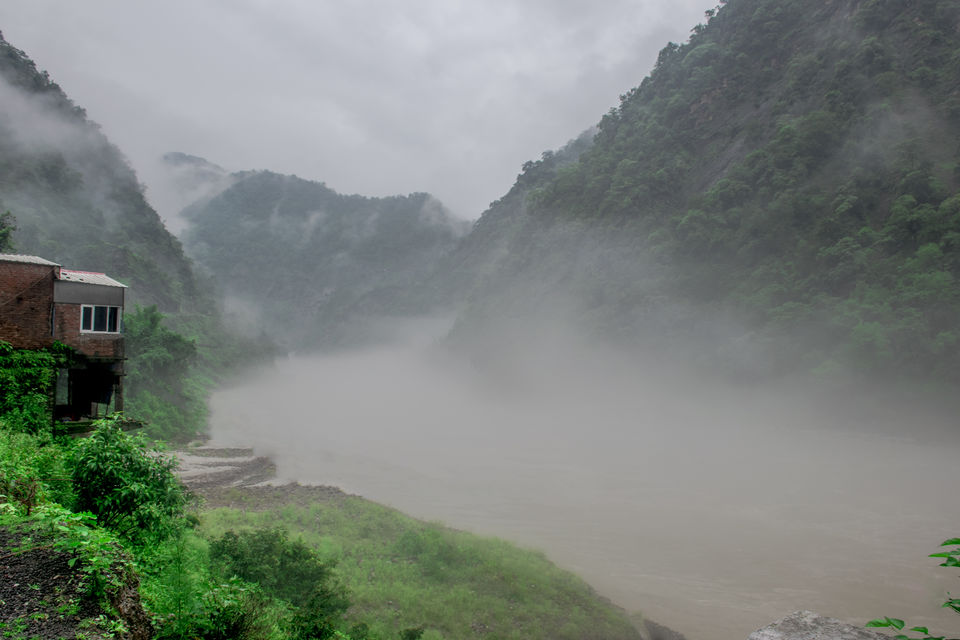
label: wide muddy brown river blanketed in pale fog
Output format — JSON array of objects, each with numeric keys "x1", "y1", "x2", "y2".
[{"x1": 212, "y1": 340, "x2": 960, "y2": 640}]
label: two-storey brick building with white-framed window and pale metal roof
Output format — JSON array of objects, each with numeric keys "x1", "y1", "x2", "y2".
[{"x1": 0, "y1": 254, "x2": 126, "y2": 422}]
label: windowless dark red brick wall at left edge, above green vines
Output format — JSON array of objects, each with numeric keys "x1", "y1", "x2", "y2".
[{"x1": 0, "y1": 262, "x2": 56, "y2": 349}]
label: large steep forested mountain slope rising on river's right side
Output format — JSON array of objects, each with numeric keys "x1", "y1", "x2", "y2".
[{"x1": 455, "y1": 0, "x2": 960, "y2": 380}]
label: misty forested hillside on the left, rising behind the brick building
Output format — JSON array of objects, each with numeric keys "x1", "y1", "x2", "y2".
[{"x1": 0, "y1": 31, "x2": 263, "y2": 438}]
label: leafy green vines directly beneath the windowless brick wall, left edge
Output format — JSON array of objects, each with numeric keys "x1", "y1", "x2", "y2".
[{"x1": 0, "y1": 341, "x2": 71, "y2": 433}]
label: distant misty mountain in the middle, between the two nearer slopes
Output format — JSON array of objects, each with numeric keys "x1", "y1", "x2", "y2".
[{"x1": 182, "y1": 171, "x2": 466, "y2": 348}]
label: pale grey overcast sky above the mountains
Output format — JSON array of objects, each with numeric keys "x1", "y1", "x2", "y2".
[{"x1": 0, "y1": 0, "x2": 715, "y2": 218}]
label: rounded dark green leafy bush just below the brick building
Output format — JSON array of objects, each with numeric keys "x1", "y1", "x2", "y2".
[{"x1": 71, "y1": 419, "x2": 187, "y2": 543}]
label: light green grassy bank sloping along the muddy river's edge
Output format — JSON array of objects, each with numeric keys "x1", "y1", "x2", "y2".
[{"x1": 202, "y1": 498, "x2": 639, "y2": 640}]
